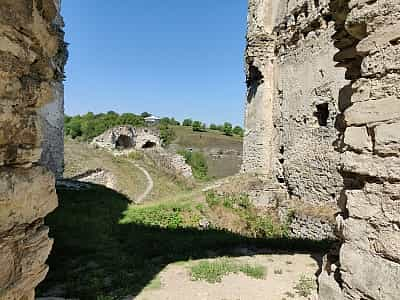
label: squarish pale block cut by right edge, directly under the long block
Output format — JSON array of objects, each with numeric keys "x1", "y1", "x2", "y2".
[{"x1": 375, "y1": 123, "x2": 400, "y2": 155}]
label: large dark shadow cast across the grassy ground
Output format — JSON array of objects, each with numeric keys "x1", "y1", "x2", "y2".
[{"x1": 38, "y1": 185, "x2": 330, "y2": 300}]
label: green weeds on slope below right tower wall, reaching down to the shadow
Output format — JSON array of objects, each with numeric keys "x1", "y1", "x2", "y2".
[{"x1": 206, "y1": 192, "x2": 288, "y2": 238}]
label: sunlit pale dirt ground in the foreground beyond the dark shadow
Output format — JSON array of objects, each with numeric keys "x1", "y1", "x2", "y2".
[{"x1": 133, "y1": 254, "x2": 320, "y2": 300}]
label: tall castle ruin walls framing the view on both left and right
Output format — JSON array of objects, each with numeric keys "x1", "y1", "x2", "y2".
[{"x1": 0, "y1": 0, "x2": 400, "y2": 300}]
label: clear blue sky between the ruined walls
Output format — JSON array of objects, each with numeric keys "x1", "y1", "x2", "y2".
[{"x1": 63, "y1": 0, "x2": 247, "y2": 124}]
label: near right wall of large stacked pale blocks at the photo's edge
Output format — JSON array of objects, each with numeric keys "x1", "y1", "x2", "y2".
[{"x1": 320, "y1": 0, "x2": 400, "y2": 300}]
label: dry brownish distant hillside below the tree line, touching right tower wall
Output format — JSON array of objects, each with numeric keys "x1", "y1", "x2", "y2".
[{"x1": 171, "y1": 126, "x2": 243, "y2": 178}]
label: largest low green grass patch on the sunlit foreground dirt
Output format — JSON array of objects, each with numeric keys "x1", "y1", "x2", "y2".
[{"x1": 191, "y1": 258, "x2": 266, "y2": 283}]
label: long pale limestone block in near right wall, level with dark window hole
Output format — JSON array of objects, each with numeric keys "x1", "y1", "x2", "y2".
[{"x1": 344, "y1": 97, "x2": 400, "y2": 126}]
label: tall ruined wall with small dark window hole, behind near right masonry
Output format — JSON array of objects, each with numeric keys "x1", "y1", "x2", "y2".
[{"x1": 243, "y1": 0, "x2": 346, "y2": 203}]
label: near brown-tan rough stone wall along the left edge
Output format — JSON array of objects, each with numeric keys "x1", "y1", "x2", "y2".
[{"x1": 0, "y1": 0, "x2": 65, "y2": 300}]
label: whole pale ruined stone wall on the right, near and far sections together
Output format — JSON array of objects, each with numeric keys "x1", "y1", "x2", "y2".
[{"x1": 243, "y1": 0, "x2": 400, "y2": 300}]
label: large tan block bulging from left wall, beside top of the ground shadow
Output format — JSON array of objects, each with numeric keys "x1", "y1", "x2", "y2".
[{"x1": 0, "y1": 167, "x2": 57, "y2": 232}]
